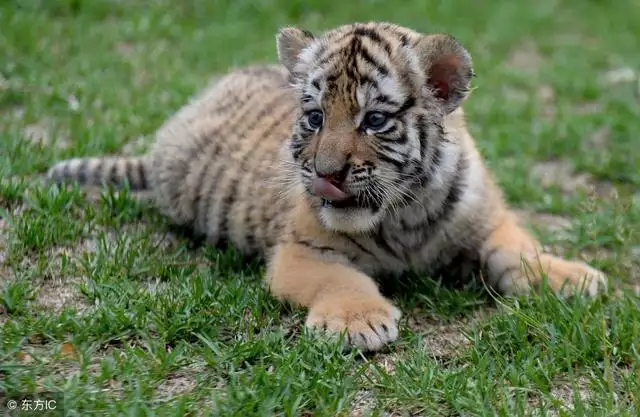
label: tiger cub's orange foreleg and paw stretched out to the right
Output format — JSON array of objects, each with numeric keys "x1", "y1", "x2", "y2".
[{"x1": 480, "y1": 211, "x2": 607, "y2": 296}]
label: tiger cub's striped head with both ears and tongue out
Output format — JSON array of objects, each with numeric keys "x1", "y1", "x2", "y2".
[{"x1": 277, "y1": 22, "x2": 472, "y2": 233}]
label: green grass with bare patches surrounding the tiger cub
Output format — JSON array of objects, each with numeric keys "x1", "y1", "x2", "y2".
[{"x1": 0, "y1": 0, "x2": 640, "y2": 416}]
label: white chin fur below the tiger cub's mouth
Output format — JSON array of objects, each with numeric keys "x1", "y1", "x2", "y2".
[{"x1": 319, "y1": 207, "x2": 384, "y2": 234}]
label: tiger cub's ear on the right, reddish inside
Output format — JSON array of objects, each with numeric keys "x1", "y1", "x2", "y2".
[{"x1": 416, "y1": 34, "x2": 473, "y2": 114}]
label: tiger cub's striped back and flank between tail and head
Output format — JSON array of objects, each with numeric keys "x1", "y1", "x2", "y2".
[{"x1": 150, "y1": 66, "x2": 297, "y2": 253}]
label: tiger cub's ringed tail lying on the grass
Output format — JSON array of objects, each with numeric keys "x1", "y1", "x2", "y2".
[{"x1": 47, "y1": 156, "x2": 151, "y2": 190}]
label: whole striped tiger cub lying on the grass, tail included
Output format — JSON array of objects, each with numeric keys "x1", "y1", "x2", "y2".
[{"x1": 49, "y1": 22, "x2": 605, "y2": 350}]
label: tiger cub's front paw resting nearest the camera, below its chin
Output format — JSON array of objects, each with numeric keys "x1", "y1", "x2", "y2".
[{"x1": 306, "y1": 294, "x2": 402, "y2": 351}]
